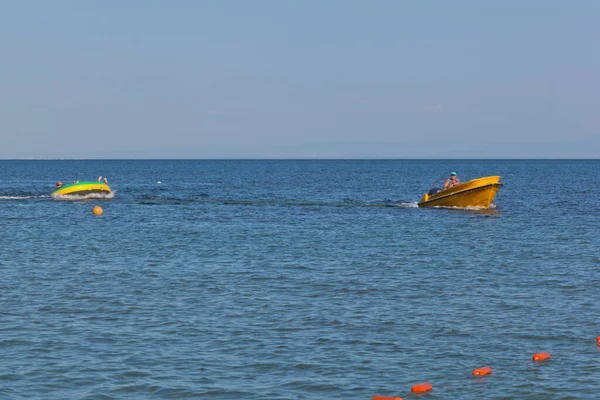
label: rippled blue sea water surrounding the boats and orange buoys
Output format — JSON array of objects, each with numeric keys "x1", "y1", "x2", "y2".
[{"x1": 0, "y1": 160, "x2": 600, "y2": 400}]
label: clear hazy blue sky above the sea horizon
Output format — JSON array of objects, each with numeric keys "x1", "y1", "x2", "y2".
[{"x1": 0, "y1": 0, "x2": 600, "y2": 158}]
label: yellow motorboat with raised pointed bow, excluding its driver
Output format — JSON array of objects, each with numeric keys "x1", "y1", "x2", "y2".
[{"x1": 418, "y1": 176, "x2": 502, "y2": 209}]
